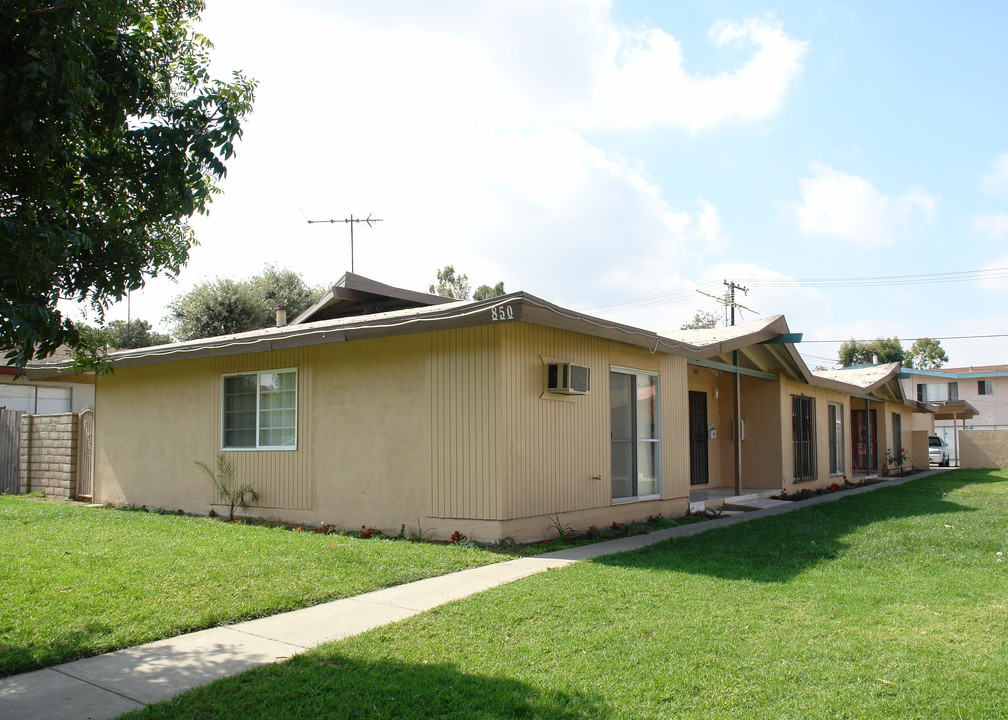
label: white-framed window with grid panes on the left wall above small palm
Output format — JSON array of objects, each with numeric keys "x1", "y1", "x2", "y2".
[{"x1": 221, "y1": 369, "x2": 297, "y2": 450}]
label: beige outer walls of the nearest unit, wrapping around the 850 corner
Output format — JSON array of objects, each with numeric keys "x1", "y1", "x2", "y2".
[{"x1": 95, "y1": 323, "x2": 688, "y2": 541}]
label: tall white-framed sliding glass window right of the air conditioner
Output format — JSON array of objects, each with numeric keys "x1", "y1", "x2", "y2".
[{"x1": 609, "y1": 368, "x2": 661, "y2": 501}]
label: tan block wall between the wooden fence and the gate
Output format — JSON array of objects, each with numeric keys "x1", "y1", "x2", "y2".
[{"x1": 20, "y1": 412, "x2": 78, "y2": 498}]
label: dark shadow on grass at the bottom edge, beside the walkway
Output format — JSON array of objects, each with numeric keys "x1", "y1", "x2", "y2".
[{"x1": 123, "y1": 652, "x2": 609, "y2": 720}]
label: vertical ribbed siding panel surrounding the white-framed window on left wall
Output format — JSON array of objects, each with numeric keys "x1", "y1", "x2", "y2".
[{"x1": 214, "y1": 348, "x2": 314, "y2": 510}]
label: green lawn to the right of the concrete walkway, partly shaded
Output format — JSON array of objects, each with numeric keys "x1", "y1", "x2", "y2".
[{"x1": 126, "y1": 471, "x2": 1008, "y2": 720}]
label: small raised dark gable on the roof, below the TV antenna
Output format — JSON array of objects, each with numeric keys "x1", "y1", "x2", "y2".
[{"x1": 290, "y1": 272, "x2": 456, "y2": 325}]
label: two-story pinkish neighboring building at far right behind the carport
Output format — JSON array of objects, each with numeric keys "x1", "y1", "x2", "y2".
[{"x1": 902, "y1": 365, "x2": 1008, "y2": 460}]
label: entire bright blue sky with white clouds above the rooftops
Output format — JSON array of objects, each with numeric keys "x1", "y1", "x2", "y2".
[{"x1": 82, "y1": 0, "x2": 1008, "y2": 367}]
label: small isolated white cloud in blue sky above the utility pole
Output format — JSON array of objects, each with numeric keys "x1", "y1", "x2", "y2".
[{"x1": 796, "y1": 162, "x2": 937, "y2": 247}]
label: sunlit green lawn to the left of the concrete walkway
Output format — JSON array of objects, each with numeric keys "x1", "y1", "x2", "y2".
[{"x1": 0, "y1": 495, "x2": 500, "y2": 677}]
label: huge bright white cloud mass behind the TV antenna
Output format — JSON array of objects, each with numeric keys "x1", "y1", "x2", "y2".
[{"x1": 90, "y1": 0, "x2": 805, "y2": 324}]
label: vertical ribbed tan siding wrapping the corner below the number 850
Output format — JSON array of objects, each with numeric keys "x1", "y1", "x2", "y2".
[{"x1": 429, "y1": 323, "x2": 689, "y2": 520}]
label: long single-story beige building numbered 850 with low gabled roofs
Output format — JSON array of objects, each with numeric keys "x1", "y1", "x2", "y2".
[{"x1": 29, "y1": 273, "x2": 926, "y2": 541}]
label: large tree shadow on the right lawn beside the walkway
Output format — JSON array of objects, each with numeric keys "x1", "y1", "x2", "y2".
[{"x1": 594, "y1": 471, "x2": 1006, "y2": 583}]
